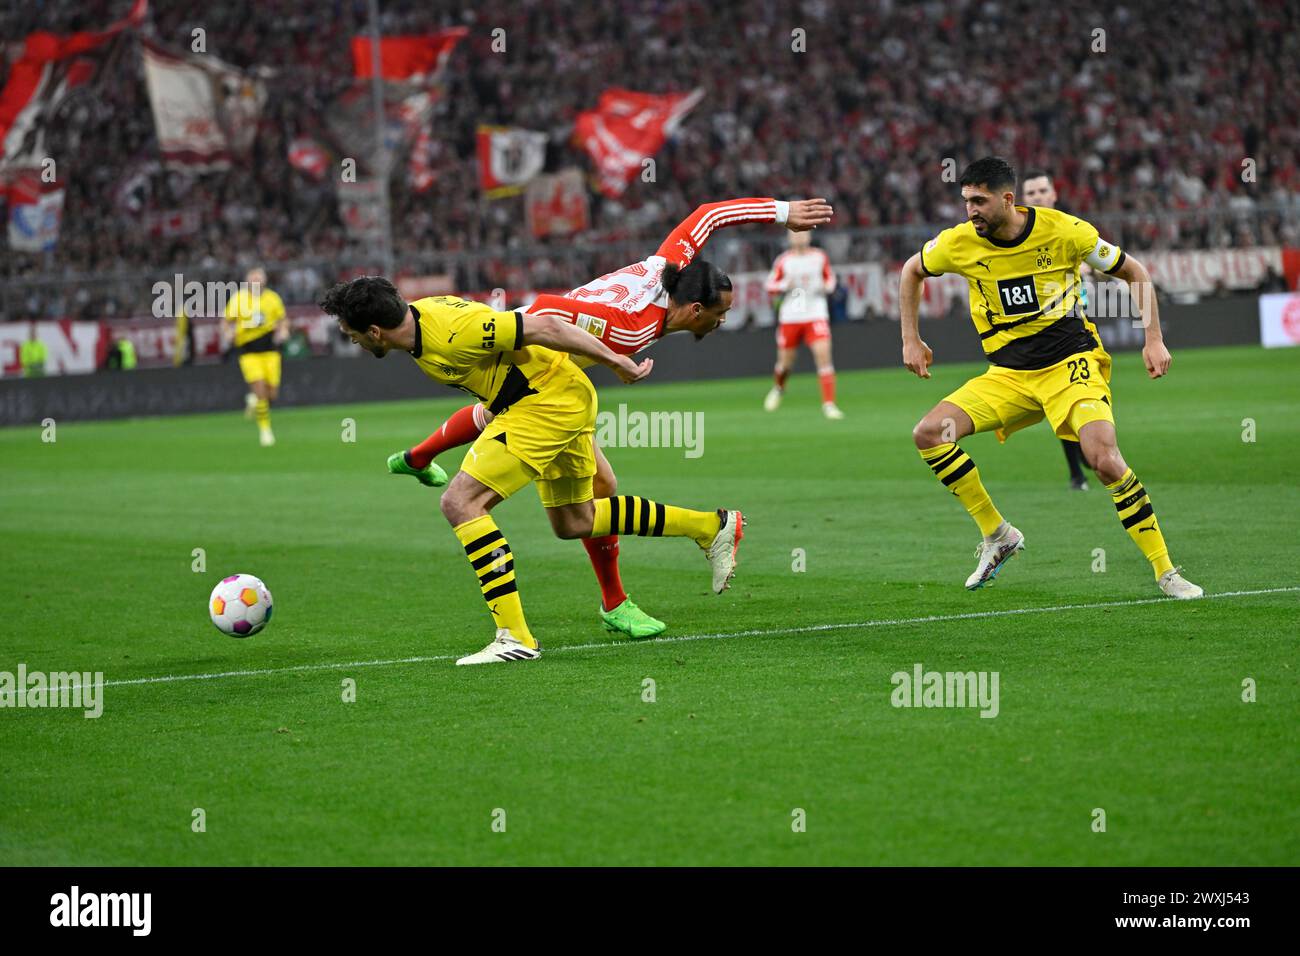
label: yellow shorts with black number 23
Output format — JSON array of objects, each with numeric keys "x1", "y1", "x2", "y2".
[{"x1": 944, "y1": 349, "x2": 1115, "y2": 441}]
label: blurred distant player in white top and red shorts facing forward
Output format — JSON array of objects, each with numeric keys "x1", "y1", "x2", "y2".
[{"x1": 763, "y1": 232, "x2": 844, "y2": 420}]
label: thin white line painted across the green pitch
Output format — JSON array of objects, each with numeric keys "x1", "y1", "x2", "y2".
[{"x1": 94, "y1": 587, "x2": 1300, "y2": 687}]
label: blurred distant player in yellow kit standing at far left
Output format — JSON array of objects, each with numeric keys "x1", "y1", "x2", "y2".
[{"x1": 221, "y1": 267, "x2": 289, "y2": 447}]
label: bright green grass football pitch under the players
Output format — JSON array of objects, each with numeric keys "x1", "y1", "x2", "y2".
[{"x1": 0, "y1": 342, "x2": 1300, "y2": 865}]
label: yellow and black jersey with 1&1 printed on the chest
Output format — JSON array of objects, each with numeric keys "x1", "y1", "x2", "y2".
[{"x1": 920, "y1": 206, "x2": 1125, "y2": 369}]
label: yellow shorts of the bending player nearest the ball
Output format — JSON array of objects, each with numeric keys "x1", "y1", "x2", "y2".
[{"x1": 460, "y1": 368, "x2": 597, "y2": 507}]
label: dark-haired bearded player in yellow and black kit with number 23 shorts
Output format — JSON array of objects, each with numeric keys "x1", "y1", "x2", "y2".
[{"x1": 898, "y1": 156, "x2": 1203, "y2": 598}]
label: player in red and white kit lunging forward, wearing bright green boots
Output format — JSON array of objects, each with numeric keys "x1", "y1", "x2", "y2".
[{"x1": 389, "y1": 198, "x2": 832, "y2": 637}]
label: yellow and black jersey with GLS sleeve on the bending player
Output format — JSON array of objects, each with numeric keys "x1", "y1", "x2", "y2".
[{"x1": 411, "y1": 295, "x2": 581, "y2": 414}]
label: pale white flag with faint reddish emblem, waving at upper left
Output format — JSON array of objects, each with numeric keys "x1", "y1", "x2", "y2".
[{"x1": 140, "y1": 40, "x2": 267, "y2": 172}]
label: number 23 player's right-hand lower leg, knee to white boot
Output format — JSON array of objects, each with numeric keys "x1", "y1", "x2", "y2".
[{"x1": 1071, "y1": 418, "x2": 1204, "y2": 598}]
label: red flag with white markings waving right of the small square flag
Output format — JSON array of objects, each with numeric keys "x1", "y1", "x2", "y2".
[{"x1": 573, "y1": 88, "x2": 705, "y2": 196}]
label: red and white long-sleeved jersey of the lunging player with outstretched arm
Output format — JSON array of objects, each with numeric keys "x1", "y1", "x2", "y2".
[{"x1": 528, "y1": 198, "x2": 784, "y2": 355}]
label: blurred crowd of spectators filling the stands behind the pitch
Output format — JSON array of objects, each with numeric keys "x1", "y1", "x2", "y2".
[{"x1": 0, "y1": 0, "x2": 1300, "y2": 317}]
